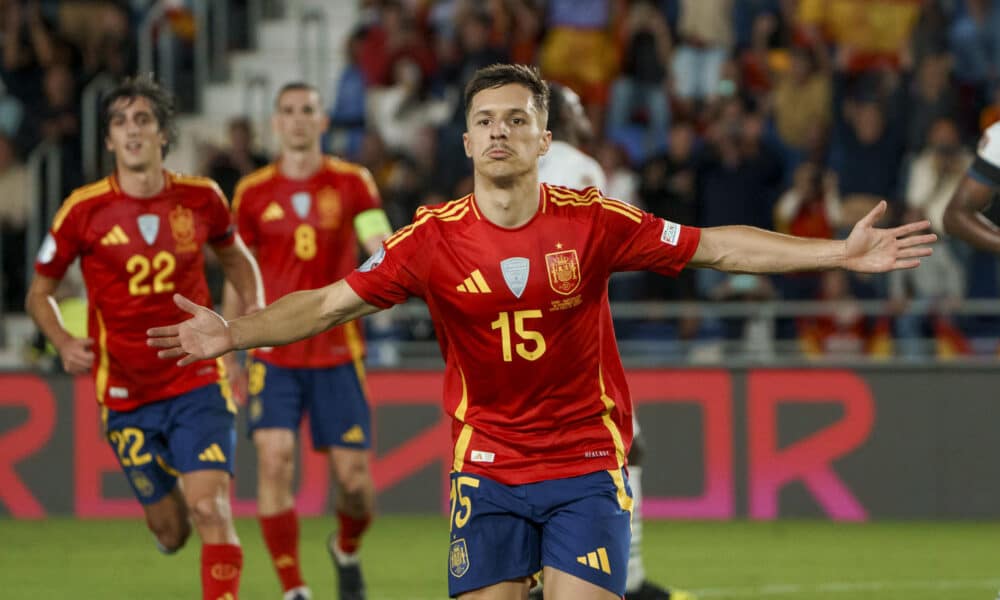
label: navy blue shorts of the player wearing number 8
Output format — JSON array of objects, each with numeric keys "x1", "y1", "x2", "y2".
[{"x1": 247, "y1": 358, "x2": 371, "y2": 449}]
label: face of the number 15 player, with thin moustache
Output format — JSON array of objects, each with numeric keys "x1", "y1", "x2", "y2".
[{"x1": 462, "y1": 84, "x2": 552, "y2": 184}]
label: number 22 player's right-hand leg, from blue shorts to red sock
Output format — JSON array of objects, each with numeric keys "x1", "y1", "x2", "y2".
[{"x1": 168, "y1": 385, "x2": 243, "y2": 600}]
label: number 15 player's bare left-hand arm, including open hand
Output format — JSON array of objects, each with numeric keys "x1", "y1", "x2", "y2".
[{"x1": 146, "y1": 280, "x2": 379, "y2": 366}]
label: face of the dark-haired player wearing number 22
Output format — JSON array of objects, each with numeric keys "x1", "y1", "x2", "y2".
[{"x1": 104, "y1": 96, "x2": 167, "y2": 171}]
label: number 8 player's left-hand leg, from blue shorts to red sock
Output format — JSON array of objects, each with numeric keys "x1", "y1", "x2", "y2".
[{"x1": 248, "y1": 360, "x2": 311, "y2": 600}]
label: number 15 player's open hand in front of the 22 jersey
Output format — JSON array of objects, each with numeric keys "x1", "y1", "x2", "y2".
[{"x1": 146, "y1": 294, "x2": 233, "y2": 367}]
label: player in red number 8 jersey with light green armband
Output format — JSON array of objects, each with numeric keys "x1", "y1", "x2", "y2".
[{"x1": 223, "y1": 83, "x2": 391, "y2": 600}]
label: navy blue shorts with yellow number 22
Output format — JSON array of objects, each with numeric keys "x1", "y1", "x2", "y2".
[{"x1": 105, "y1": 384, "x2": 236, "y2": 504}]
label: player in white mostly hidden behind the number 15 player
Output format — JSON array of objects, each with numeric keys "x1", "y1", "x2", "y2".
[{"x1": 531, "y1": 83, "x2": 694, "y2": 600}]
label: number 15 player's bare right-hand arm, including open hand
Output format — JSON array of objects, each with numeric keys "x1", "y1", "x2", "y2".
[{"x1": 690, "y1": 201, "x2": 937, "y2": 273}]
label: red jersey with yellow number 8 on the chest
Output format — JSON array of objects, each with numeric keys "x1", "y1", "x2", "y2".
[{"x1": 233, "y1": 158, "x2": 382, "y2": 368}]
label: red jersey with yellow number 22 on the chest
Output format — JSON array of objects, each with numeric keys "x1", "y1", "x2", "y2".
[{"x1": 35, "y1": 171, "x2": 233, "y2": 411}]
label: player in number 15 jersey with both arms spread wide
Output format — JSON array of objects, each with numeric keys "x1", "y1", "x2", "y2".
[{"x1": 149, "y1": 65, "x2": 935, "y2": 600}]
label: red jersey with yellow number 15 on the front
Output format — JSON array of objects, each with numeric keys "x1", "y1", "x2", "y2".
[{"x1": 347, "y1": 184, "x2": 700, "y2": 484}]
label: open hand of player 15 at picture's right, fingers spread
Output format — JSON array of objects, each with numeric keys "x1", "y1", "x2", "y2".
[{"x1": 844, "y1": 200, "x2": 937, "y2": 273}]
